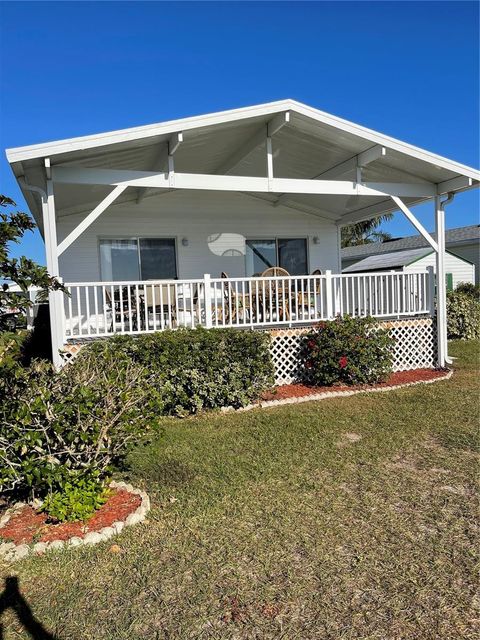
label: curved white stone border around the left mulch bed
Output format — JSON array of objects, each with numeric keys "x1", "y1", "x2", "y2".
[{"x1": 0, "y1": 480, "x2": 150, "y2": 562}]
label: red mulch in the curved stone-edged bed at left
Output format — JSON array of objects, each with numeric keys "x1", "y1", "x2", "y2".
[{"x1": 0, "y1": 489, "x2": 142, "y2": 544}]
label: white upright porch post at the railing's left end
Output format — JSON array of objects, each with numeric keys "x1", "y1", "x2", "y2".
[{"x1": 42, "y1": 172, "x2": 64, "y2": 369}]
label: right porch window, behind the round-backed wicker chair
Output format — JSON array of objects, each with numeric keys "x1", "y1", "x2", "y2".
[{"x1": 246, "y1": 238, "x2": 308, "y2": 276}]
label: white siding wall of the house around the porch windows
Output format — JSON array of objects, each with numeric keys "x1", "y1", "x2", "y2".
[{"x1": 57, "y1": 191, "x2": 339, "y2": 282}]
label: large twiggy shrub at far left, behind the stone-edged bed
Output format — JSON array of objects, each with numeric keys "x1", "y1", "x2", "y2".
[{"x1": 0, "y1": 352, "x2": 158, "y2": 498}]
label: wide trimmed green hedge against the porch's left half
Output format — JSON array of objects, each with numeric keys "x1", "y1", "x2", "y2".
[{"x1": 80, "y1": 328, "x2": 273, "y2": 416}]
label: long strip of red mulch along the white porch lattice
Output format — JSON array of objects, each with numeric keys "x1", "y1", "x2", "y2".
[{"x1": 262, "y1": 369, "x2": 445, "y2": 400}]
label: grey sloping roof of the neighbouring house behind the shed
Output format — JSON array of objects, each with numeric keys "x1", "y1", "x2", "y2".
[{"x1": 342, "y1": 224, "x2": 480, "y2": 260}]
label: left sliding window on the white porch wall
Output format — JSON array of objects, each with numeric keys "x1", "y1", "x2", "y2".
[{"x1": 100, "y1": 238, "x2": 177, "y2": 281}]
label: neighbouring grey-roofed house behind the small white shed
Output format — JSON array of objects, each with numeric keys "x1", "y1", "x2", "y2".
[{"x1": 342, "y1": 224, "x2": 480, "y2": 284}]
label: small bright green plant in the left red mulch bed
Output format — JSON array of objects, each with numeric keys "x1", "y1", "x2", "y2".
[{"x1": 40, "y1": 474, "x2": 110, "y2": 522}]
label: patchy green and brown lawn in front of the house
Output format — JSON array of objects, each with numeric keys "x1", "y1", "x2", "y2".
[{"x1": 3, "y1": 342, "x2": 479, "y2": 640}]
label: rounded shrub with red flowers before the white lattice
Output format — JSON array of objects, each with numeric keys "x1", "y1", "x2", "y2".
[{"x1": 302, "y1": 316, "x2": 394, "y2": 385}]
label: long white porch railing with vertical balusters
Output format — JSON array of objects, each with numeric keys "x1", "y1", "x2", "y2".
[{"x1": 64, "y1": 270, "x2": 434, "y2": 339}]
